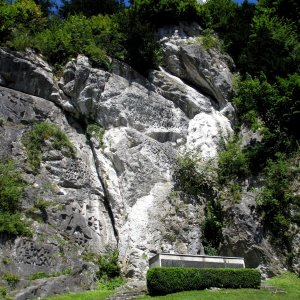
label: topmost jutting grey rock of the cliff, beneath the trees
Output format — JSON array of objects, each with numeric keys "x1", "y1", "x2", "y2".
[{"x1": 157, "y1": 24, "x2": 233, "y2": 109}]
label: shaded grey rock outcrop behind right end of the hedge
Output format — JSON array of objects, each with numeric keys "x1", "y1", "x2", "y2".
[{"x1": 221, "y1": 192, "x2": 284, "y2": 277}]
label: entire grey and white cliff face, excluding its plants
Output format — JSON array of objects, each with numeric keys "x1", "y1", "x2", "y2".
[{"x1": 0, "y1": 24, "x2": 296, "y2": 299}]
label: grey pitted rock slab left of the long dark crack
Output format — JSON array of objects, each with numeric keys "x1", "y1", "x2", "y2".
[{"x1": 0, "y1": 87, "x2": 116, "y2": 299}]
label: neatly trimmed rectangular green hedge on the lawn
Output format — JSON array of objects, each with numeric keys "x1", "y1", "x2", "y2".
[{"x1": 147, "y1": 268, "x2": 260, "y2": 296}]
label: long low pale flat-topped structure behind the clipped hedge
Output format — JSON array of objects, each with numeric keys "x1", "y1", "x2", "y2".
[{"x1": 149, "y1": 253, "x2": 245, "y2": 268}]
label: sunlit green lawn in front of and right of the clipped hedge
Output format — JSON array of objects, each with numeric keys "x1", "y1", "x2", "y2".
[{"x1": 138, "y1": 273, "x2": 300, "y2": 300}]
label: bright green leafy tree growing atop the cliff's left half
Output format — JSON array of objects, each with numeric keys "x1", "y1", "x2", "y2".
[{"x1": 34, "y1": 15, "x2": 125, "y2": 69}]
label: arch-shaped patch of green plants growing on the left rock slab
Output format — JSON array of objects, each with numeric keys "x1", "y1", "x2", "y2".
[{"x1": 22, "y1": 122, "x2": 75, "y2": 171}]
